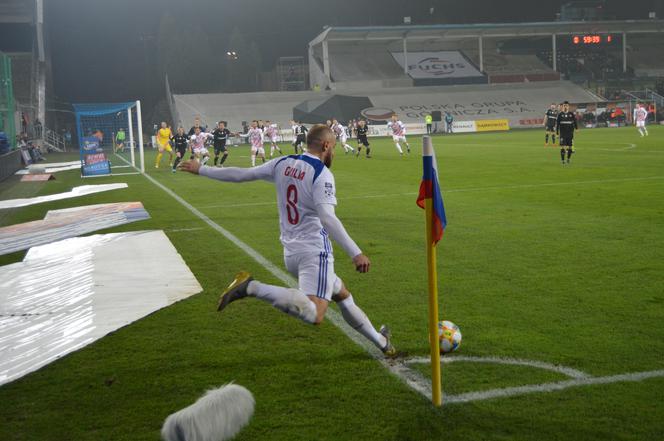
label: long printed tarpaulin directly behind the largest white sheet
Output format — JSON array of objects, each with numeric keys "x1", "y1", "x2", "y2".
[{"x1": 0, "y1": 202, "x2": 150, "y2": 255}]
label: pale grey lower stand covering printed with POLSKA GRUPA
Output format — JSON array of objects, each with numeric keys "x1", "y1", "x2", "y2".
[{"x1": 173, "y1": 81, "x2": 597, "y2": 131}]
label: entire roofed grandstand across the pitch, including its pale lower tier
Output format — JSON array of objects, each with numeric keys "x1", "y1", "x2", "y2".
[{"x1": 167, "y1": 20, "x2": 664, "y2": 134}]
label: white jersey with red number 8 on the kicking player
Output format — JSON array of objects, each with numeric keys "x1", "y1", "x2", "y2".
[{"x1": 249, "y1": 153, "x2": 337, "y2": 256}]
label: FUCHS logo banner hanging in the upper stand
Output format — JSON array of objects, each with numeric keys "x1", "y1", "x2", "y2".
[{"x1": 391, "y1": 51, "x2": 484, "y2": 80}]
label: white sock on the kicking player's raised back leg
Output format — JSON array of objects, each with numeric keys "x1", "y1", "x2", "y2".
[{"x1": 247, "y1": 280, "x2": 317, "y2": 323}]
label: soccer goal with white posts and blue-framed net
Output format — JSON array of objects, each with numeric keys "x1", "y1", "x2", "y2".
[{"x1": 74, "y1": 101, "x2": 145, "y2": 176}]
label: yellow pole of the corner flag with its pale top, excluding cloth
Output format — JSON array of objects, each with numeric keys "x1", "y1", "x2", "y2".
[{"x1": 422, "y1": 136, "x2": 443, "y2": 407}]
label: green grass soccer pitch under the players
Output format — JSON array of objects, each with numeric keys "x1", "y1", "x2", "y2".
[{"x1": 0, "y1": 127, "x2": 664, "y2": 441}]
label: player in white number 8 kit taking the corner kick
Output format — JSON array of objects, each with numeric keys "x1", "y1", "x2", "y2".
[{"x1": 182, "y1": 125, "x2": 396, "y2": 356}]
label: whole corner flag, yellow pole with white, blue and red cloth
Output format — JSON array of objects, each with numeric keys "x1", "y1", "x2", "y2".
[{"x1": 417, "y1": 136, "x2": 447, "y2": 406}]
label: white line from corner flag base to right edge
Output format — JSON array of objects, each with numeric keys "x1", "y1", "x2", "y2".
[{"x1": 443, "y1": 370, "x2": 664, "y2": 404}]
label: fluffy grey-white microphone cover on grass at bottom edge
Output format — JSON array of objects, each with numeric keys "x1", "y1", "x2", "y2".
[{"x1": 161, "y1": 384, "x2": 256, "y2": 441}]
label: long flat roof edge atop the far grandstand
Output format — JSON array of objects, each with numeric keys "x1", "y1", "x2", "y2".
[{"x1": 309, "y1": 20, "x2": 664, "y2": 46}]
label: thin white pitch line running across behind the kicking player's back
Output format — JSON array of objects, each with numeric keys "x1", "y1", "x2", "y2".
[{"x1": 201, "y1": 176, "x2": 664, "y2": 209}]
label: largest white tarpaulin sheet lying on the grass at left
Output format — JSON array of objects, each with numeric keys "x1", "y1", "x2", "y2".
[{"x1": 0, "y1": 231, "x2": 202, "y2": 384}]
